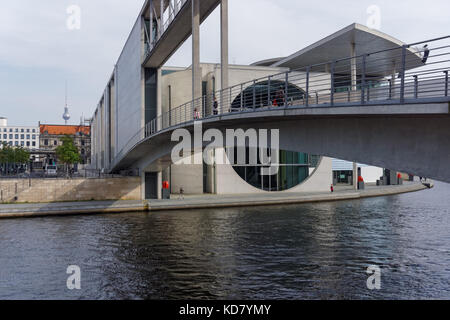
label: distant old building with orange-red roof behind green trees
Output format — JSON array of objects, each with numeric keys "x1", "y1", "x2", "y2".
[{"x1": 39, "y1": 124, "x2": 91, "y2": 164}]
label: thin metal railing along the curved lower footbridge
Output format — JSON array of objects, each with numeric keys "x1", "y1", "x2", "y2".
[{"x1": 109, "y1": 36, "x2": 450, "y2": 167}]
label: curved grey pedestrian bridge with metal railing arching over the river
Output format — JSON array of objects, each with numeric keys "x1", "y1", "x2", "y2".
[{"x1": 112, "y1": 36, "x2": 450, "y2": 182}]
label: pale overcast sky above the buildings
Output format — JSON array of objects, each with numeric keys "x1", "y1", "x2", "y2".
[{"x1": 0, "y1": 0, "x2": 450, "y2": 125}]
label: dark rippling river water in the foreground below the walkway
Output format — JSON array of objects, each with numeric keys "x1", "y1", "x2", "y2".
[{"x1": 0, "y1": 183, "x2": 450, "y2": 299}]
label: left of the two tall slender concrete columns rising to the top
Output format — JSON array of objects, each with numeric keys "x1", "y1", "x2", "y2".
[{"x1": 192, "y1": 0, "x2": 202, "y2": 99}]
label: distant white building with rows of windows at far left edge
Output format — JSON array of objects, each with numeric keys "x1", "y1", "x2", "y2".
[{"x1": 0, "y1": 117, "x2": 39, "y2": 150}]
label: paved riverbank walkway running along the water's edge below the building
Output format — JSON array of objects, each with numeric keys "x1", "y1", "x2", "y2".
[{"x1": 0, "y1": 182, "x2": 427, "y2": 219}]
